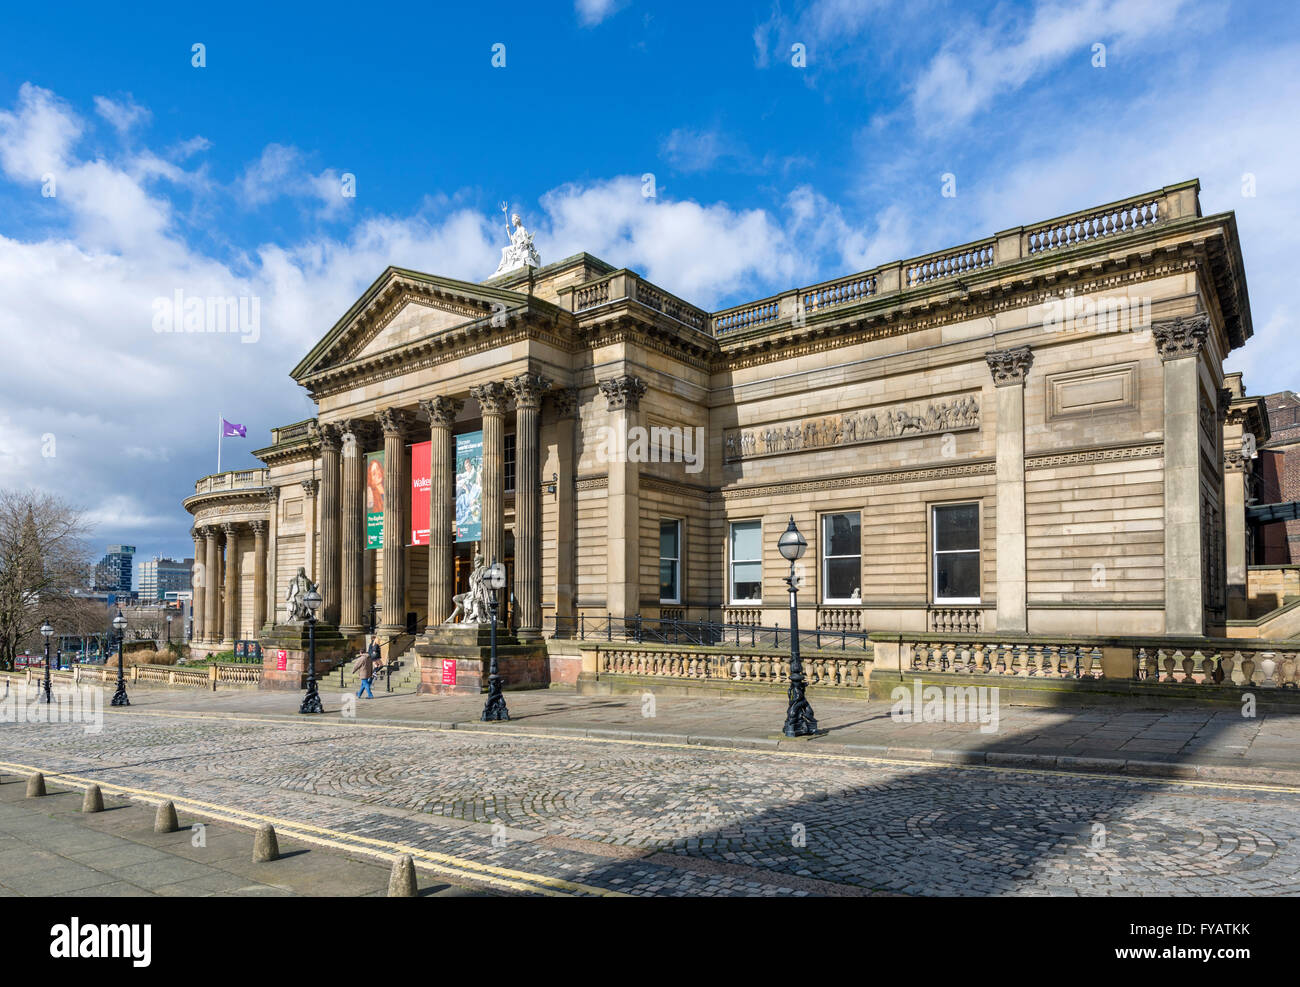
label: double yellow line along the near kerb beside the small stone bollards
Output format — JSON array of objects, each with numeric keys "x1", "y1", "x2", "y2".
[{"x1": 0, "y1": 761, "x2": 629, "y2": 897}]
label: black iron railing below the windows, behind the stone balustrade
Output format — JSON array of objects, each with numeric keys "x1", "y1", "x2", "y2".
[{"x1": 542, "y1": 614, "x2": 871, "y2": 651}]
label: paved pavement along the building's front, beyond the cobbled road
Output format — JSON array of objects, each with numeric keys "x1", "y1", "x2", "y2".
[{"x1": 45, "y1": 679, "x2": 1300, "y2": 785}]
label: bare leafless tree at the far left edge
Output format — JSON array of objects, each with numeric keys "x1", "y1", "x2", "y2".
[{"x1": 0, "y1": 490, "x2": 92, "y2": 668}]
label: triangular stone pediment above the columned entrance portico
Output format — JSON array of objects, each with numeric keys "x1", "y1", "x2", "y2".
[{"x1": 290, "y1": 268, "x2": 530, "y2": 381}]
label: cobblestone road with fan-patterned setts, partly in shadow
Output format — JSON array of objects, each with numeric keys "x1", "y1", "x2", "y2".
[{"x1": 0, "y1": 710, "x2": 1300, "y2": 895}]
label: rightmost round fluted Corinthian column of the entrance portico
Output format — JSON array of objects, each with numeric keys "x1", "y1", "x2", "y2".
[{"x1": 510, "y1": 373, "x2": 551, "y2": 640}]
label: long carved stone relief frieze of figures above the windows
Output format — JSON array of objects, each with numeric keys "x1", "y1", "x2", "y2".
[{"x1": 724, "y1": 395, "x2": 980, "y2": 462}]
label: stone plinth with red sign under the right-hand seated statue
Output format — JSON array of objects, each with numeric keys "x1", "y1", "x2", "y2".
[{"x1": 415, "y1": 624, "x2": 550, "y2": 696}]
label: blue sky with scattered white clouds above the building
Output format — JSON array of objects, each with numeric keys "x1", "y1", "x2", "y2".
[{"x1": 0, "y1": 0, "x2": 1300, "y2": 574}]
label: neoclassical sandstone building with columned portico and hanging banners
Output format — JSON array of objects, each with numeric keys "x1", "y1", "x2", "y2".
[{"x1": 186, "y1": 181, "x2": 1266, "y2": 660}]
